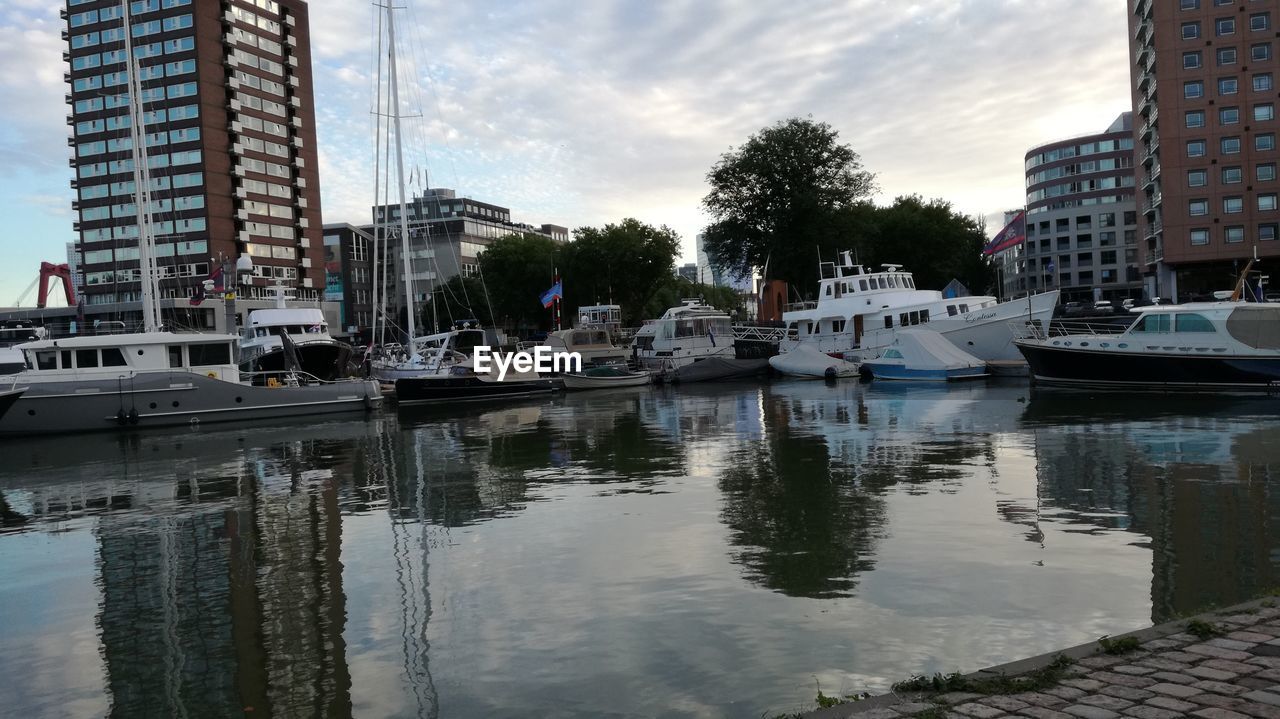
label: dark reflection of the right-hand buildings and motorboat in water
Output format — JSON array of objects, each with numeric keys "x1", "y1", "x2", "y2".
[{"x1": 1027, "y1": 397, "x2": 1280, "y2": 622}]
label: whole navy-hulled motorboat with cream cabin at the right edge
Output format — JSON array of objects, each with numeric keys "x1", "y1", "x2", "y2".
[{"x1": 1015, "y1": 301, "x2": 1280, "y2": 393}]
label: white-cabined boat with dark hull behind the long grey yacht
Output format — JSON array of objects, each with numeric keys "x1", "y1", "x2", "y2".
[{"x1": 239, "y1": 285, "x2": 352, "y2": 380}]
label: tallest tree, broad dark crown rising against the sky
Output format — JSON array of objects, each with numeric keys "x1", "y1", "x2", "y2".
[{"x1": 703, "y1": 118, "x2": 876, "y2": 290}]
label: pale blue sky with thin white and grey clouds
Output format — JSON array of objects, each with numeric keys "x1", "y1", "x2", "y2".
[{"x1": 0, "y1": 0, "x2": 1130, "y2": 307}]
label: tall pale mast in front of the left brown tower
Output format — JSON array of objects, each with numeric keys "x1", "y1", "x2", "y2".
[{"x1": 120, "y1": 0, "x2": 160, "y2": 333}]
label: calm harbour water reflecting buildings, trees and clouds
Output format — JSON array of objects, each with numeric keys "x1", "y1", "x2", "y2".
[{"x1": 0, "y1": 381, "x2": 1280, "y2": 718}]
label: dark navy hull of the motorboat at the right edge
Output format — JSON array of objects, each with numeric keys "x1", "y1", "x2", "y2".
[{"x1": 1018, "y1": 340, "x2": 1280, "y2": 391}]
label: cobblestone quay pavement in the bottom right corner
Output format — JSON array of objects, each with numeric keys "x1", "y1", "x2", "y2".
[{"x1": 810, "y1": 601, "x2": 1280, "y2": 719}]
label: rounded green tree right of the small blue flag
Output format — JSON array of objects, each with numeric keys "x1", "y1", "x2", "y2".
[{"x1": 560, "y1": 217, "x2": 680, "y2": 324}]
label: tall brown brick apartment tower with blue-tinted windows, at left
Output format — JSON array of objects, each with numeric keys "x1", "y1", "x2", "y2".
[{"x1": 63, "y1": 0, "x2": 324, "y2": 304}]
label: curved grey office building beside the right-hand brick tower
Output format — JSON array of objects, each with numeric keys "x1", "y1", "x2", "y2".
[{"x1": 1018, "y1": 113, "x2": 1142, "y2": 302}]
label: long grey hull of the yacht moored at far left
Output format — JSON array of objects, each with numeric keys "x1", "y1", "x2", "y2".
[{"x1": 0, "y1": 372, "x2": 381, "y2": 436}]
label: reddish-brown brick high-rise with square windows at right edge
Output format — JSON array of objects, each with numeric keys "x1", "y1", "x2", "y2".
[{"x1": 1126, "y1": 0, "x2": 1280, "y2": 301}]
